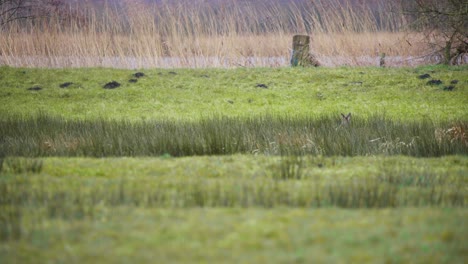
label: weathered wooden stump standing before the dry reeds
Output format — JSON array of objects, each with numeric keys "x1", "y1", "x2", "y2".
[{"x1": 291, "y1": 35, "x2": 320, "y2": 67}]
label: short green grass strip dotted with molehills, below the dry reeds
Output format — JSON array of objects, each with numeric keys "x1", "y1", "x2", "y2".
[{"x1": 0, "y1": 66, "x2": 468, "y2": 121}]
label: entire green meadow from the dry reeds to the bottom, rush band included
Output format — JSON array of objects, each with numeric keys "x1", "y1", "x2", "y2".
[{"x1": 0, "y1": 66, "x2": 468, "y2": 263}]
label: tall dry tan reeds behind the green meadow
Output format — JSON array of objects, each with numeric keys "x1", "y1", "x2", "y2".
[{"x1": 0, "y1": 0, "x2": 436, "y2": 68}]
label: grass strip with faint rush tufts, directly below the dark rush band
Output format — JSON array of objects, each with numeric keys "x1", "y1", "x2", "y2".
[{"x1": 0, "y1": 155, "x2": 468, "y2": 208}]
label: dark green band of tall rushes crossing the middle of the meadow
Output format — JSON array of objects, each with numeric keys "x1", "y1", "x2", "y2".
[{"x1": 0, "y1": 114, "x2": 468, "y2": 157}]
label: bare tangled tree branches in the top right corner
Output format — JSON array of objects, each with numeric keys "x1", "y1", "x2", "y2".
[{"x1": 401, "y1": 0, "x2": 468, "y2": 64}]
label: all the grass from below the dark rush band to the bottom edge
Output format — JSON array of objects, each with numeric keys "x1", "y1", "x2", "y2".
[{"x1": 0, "y1": 155, "x2": 468, "y2": 263}]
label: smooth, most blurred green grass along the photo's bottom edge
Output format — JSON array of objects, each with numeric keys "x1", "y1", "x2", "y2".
[{"x1": 0, "y1": 207, "x2": 468, "y2": 263}]
